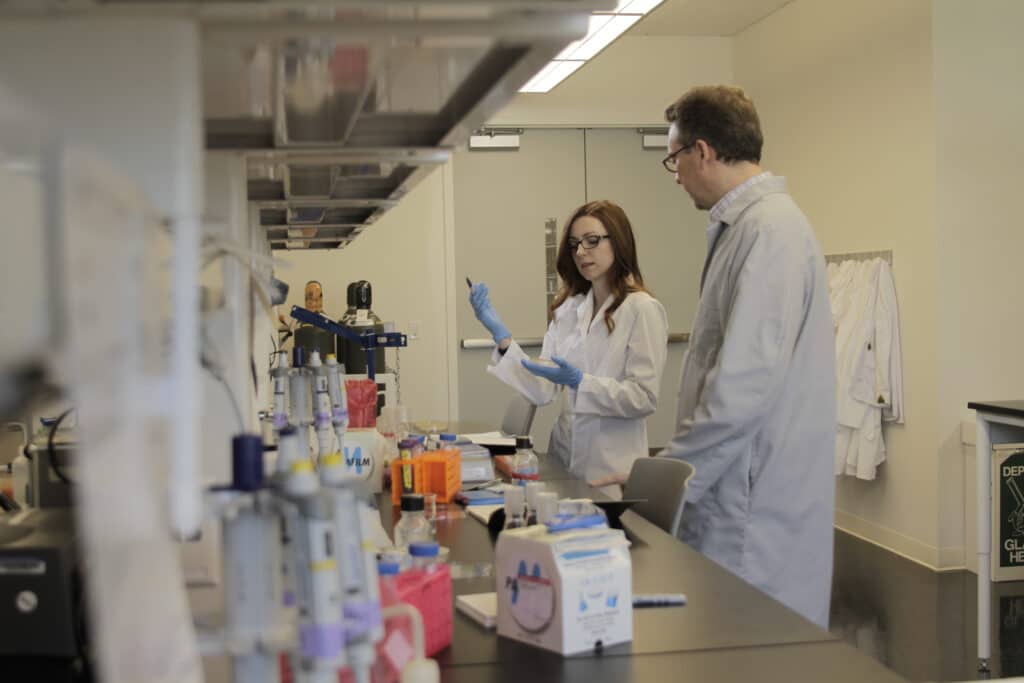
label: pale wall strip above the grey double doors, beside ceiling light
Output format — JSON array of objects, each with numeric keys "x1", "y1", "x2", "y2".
[{"x1": 489, "y1": 36, "x2": 732, "y2": 128}]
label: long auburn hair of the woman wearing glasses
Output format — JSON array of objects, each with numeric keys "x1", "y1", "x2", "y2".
[{"x1": 551, "y1": 200, "x2": 650, "y2": 334}]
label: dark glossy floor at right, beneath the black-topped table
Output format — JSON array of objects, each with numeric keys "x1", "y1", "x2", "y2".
[{"x1": 831, "y1": 531, "x2": 1024, "y2": 681}]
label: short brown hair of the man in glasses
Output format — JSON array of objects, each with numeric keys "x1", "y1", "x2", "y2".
[{"x1": 665, "y1": 85, "x2": 764, "y2": 164}]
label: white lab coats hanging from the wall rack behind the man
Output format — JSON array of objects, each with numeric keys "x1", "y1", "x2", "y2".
[{"x1": 828, "y1": 259, "x2": 903, "y2": 480}]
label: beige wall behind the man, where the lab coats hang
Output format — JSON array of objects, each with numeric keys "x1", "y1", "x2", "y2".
[{"x1": 734, "y1": 0, "x2": 942, "y2": 565}]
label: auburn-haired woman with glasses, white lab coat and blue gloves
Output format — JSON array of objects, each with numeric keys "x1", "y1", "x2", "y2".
[{"x1": 469, "y1": 201, "x2": 669, "y2": 481}]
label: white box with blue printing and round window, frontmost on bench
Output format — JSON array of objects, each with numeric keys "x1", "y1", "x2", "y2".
[{"x1": 496, "y1": 524, "x2": 633, "y2": 654}]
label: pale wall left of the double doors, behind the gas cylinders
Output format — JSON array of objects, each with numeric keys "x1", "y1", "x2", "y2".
[{"x1": 274, "y1": 166, "x2": 456, "y2": 421}]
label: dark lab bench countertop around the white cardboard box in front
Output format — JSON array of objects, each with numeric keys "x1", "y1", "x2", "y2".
[{"x1": 382, "y1": 456, "x2": 903, "y2": 683}]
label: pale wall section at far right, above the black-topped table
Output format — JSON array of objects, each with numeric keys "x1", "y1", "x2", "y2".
[{"x1": 933, "y1": 0, "x2": 1024, "y2": 561}]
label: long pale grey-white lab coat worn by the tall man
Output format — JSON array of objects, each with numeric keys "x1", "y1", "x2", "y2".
[{"x1": 660, "y1": 176, "x2": 836, "y2": 628}]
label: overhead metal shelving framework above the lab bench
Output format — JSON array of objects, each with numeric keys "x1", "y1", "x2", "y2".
[{"x1": 0, "y1": 0, "x2": 616, "y2": 249}]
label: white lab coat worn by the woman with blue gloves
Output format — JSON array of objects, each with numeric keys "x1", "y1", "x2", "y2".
[{"x1": 487, "y1": 292, "x2": 669, "y2": 481}]
